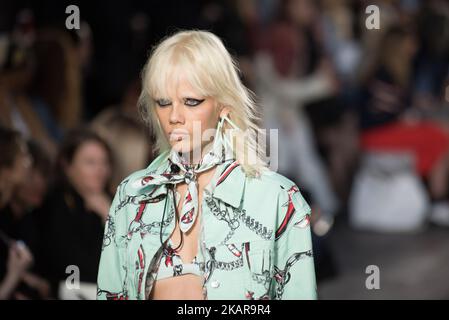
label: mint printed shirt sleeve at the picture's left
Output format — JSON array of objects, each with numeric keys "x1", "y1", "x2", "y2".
[{"x1": 97, "y1": 185, "x2": 127, "y2": 300}]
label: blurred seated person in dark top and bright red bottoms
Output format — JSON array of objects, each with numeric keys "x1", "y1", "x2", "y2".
[{"x1": 359, "y1": 24, "x2": 449, "y2": 225}]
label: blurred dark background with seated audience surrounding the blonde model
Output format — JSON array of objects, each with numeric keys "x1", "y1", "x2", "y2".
[{"x1": 0, "y1": 0, "x2": 449, "y2": 299}]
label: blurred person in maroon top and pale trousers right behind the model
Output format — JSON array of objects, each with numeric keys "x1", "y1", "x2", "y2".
[{"x1": 254, "y1": 0, "x2": 339, "y2": 234}]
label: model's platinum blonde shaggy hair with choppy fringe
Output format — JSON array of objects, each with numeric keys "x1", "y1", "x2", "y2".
[{"x1": 138, "y1": 30, "x2": 267, "y2": 177}]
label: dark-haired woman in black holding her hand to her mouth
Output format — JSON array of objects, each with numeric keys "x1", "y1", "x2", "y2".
[{"x1": 35, "y1": 130, "x2": 112, "y2": 298}]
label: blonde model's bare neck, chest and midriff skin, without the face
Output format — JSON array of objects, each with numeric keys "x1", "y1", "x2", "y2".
[{"x1": 150, "y1": 167, "x2": 216, "y2": 300}]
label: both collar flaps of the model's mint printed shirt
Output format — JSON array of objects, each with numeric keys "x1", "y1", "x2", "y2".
[{"x1": 132, "y1": 151, "x2": 246, "y2": 208}]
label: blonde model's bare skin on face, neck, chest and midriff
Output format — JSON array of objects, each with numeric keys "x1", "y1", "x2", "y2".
[{"x1": 150, "y1": 73, "x2": 230, "y2": 300}]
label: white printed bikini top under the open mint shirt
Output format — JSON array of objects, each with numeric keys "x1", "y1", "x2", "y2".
[{"x1": 156, "y1": 239, "x2": 204, "y2": 280}]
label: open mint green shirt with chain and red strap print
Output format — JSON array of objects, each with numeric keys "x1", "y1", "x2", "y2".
[{"x1": 97, "y1": 152, "x2": 316, "y2": 300}]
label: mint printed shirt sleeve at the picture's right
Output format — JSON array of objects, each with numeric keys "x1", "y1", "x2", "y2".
[{"x1": 273, "y1": 184, "x2": 317, "y2": 300}]
